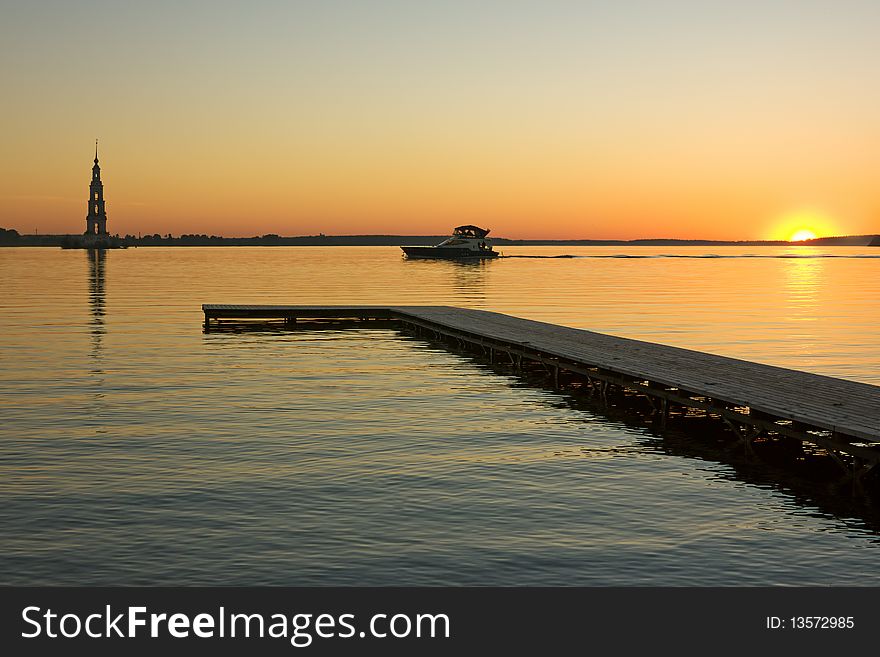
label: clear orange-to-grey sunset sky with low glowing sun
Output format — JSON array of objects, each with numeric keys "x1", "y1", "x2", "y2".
[{"x1": 0, "y1": 0, "x2": 880, "y2": 239}]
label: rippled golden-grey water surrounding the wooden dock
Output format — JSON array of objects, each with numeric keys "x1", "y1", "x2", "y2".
[{"x1": 0, "y1": 247, "x2": 880, "y2": 585}]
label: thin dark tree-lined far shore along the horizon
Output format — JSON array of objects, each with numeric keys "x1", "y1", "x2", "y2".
[{"x1": 0, "y1": 228, "x2": 880, "y2": 246}]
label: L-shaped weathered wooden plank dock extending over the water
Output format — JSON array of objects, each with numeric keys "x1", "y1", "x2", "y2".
[{"x1": 202, "y1": 304, "x2": 880, "y2": 481}]
